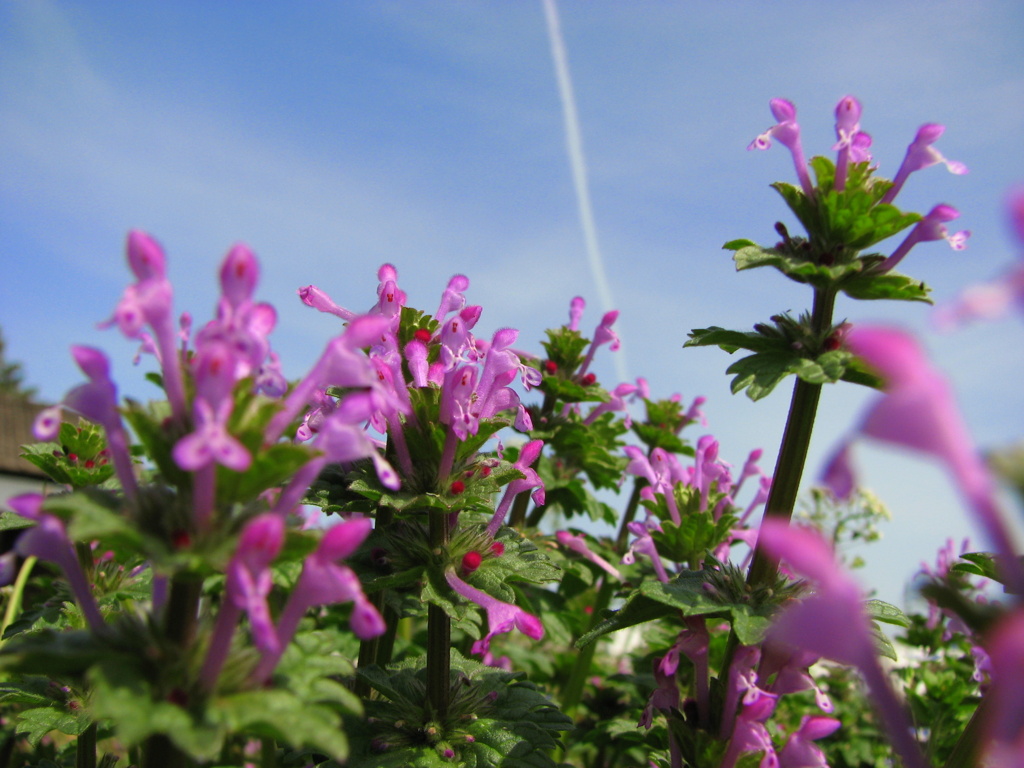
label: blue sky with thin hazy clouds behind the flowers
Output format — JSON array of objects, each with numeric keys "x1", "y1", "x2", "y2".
[{"x1": 0, "y1": 0, "x2": 1024, "y2": 598}]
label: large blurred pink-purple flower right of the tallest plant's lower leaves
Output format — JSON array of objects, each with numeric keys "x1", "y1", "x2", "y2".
[{"x1": 826, "y1": 327, "x2": 1024, "y2": 593}]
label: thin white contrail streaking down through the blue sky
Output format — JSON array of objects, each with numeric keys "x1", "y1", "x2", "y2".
[{"x1": 543, "y1": 0, "x2": 630, "y2": 381}]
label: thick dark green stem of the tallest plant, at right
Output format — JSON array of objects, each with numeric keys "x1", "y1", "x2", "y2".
[{"x1": 746, "y1": 288, "x2": 836, "y2": 586}]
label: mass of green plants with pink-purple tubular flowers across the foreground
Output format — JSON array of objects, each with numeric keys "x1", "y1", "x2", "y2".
[{"x1": 0, "y1": 96, "x2": 1024, "y2": 768}]
